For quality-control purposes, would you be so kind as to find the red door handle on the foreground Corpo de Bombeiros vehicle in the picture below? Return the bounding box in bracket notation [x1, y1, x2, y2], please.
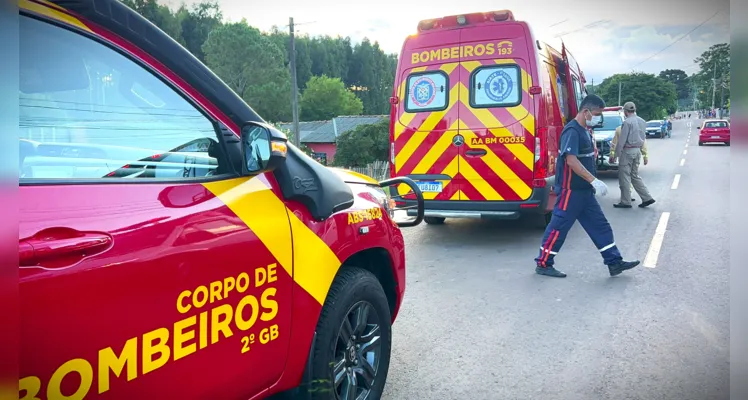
[18, 228, 112, 268]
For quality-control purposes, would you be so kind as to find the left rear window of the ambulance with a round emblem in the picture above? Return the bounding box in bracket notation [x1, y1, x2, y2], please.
[405, 71, 449, 113]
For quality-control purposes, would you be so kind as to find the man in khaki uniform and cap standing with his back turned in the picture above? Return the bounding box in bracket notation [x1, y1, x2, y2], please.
[610, 101, 655, 208]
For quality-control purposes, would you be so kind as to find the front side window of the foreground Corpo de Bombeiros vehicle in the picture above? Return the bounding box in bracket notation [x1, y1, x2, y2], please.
[19, 16, 225, 182]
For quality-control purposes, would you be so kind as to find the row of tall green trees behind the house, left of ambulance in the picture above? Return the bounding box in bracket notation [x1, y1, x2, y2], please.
[121, 0, 397, 121]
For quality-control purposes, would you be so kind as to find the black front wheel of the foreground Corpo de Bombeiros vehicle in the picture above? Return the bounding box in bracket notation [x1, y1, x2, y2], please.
[309, 267, 392, 400]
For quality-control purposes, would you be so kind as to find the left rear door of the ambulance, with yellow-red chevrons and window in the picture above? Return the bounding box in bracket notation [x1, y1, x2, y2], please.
[392, 30, 460, 200]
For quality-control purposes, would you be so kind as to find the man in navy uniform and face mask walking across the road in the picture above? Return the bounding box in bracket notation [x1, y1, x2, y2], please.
[535, 95, 639, 278]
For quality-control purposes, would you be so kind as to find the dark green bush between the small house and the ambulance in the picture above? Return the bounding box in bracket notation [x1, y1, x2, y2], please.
[335, 119, 390, 167]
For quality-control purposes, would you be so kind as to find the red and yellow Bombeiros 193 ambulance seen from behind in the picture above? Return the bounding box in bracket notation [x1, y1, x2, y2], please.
[390, 10, 586, 227]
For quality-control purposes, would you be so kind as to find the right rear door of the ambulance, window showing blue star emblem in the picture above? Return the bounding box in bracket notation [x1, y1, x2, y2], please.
[459, 22, 537, 201]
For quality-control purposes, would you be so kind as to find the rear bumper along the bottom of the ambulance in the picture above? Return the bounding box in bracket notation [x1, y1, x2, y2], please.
[405, 177, 555, 219]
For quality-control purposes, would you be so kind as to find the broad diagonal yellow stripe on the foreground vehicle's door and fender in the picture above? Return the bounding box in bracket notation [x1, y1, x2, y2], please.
[203, 177, 341, 305]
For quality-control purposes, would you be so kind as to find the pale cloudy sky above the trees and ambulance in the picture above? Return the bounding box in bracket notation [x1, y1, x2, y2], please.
[161, 0, 730, 83]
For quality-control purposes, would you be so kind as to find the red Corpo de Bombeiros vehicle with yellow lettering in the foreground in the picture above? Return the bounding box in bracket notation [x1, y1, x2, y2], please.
[18, 0, 423, 400]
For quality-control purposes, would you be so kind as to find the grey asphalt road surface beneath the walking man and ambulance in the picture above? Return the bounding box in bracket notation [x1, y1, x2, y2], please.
[384, 116, 730, 400]
